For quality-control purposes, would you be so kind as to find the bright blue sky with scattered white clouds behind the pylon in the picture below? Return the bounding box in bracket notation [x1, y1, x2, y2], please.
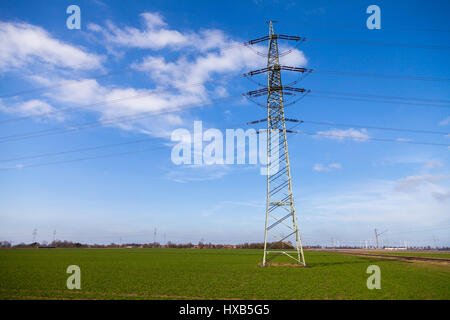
[0, 1, 450, 246]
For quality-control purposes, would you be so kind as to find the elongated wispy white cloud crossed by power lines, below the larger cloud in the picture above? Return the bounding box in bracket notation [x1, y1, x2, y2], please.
[38, 79, 200, 137]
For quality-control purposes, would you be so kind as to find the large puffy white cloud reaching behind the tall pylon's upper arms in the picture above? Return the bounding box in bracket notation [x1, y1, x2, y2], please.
[93, 12, 306, 92]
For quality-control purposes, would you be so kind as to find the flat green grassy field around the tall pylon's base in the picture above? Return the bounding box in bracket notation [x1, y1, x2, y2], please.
[0, 249, 450, 299]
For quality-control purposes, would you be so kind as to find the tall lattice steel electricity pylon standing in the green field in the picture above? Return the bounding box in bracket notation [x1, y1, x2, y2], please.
[244, 21, 311, 266]
